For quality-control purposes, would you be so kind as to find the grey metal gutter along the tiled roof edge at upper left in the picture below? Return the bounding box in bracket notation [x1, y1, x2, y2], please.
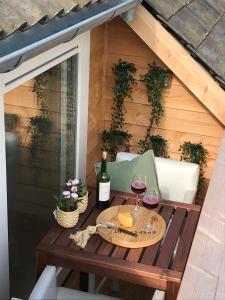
[0, 0, 141, 73]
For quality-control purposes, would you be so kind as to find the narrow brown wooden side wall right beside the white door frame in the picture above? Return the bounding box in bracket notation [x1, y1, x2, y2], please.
[87, 25, 105, 185]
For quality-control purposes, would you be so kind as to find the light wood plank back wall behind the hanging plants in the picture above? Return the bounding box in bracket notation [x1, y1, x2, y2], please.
[89, 17, 223, 199]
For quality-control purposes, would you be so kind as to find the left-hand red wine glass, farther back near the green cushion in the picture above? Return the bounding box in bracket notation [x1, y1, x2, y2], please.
[131, 173, 146, 214]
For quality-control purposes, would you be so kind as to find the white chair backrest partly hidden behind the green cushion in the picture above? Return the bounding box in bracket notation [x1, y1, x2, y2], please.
[116, 152, 199, 203]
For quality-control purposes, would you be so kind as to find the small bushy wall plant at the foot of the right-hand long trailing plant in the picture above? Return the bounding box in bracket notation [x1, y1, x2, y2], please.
[138, 135, 169, 158]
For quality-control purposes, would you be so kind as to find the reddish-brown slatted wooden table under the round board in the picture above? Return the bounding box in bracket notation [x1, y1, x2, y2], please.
[36, 189, 200, 300]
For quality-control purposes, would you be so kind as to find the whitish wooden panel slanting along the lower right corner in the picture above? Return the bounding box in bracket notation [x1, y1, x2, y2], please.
[177, 135, 225, 300]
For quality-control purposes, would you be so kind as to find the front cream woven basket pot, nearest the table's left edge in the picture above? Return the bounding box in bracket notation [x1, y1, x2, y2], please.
[56, 206, 79, 228]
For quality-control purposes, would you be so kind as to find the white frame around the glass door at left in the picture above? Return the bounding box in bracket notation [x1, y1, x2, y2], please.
[0, 31, 90, 299]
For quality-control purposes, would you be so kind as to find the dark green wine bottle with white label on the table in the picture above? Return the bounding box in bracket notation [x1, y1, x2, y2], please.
[96, 151, 110, 210]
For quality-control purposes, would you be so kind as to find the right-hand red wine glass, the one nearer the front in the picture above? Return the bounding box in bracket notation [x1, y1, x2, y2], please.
[142, 188, 160, 233]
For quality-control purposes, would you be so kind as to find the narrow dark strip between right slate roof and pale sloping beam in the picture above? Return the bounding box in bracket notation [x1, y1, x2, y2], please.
[142, 1, 225, 90]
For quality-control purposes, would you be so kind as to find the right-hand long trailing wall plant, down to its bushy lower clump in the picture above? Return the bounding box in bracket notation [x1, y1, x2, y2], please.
[138, 64, 172, 157]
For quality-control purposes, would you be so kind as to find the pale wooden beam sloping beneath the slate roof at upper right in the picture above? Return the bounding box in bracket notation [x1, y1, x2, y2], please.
[125, 5, 225, 125]
